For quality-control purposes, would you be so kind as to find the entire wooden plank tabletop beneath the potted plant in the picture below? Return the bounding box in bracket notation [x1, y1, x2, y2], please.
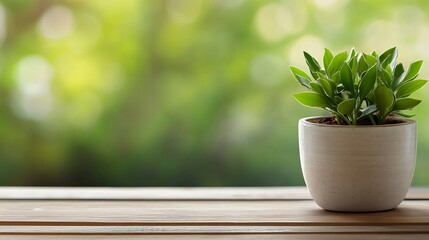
[0, 187, 429, 240]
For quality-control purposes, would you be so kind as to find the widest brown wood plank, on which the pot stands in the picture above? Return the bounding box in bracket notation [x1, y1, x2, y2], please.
[0, 200, 429, 226]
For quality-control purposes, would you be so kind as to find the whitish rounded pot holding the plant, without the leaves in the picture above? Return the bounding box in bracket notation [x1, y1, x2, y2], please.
[299, 118, 417, 212]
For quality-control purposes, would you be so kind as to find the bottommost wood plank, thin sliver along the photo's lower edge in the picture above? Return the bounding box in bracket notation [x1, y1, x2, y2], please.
[1, 233, 429, 240]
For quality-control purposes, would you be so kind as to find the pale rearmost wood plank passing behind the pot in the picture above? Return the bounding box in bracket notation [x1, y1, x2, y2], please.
[0, 187, 429, 201]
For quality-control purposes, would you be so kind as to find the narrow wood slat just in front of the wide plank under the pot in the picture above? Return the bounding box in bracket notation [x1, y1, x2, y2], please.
[0, 224, 429, 235]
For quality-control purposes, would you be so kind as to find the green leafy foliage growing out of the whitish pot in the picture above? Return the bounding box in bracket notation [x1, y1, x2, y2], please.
[290, 47, 427, 125]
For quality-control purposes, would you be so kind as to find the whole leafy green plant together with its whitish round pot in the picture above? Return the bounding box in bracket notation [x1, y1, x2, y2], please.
[290, 47, 427, 212]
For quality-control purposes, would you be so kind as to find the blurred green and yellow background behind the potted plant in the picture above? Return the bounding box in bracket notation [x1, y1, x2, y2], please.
[0, 0, 429, 186]
